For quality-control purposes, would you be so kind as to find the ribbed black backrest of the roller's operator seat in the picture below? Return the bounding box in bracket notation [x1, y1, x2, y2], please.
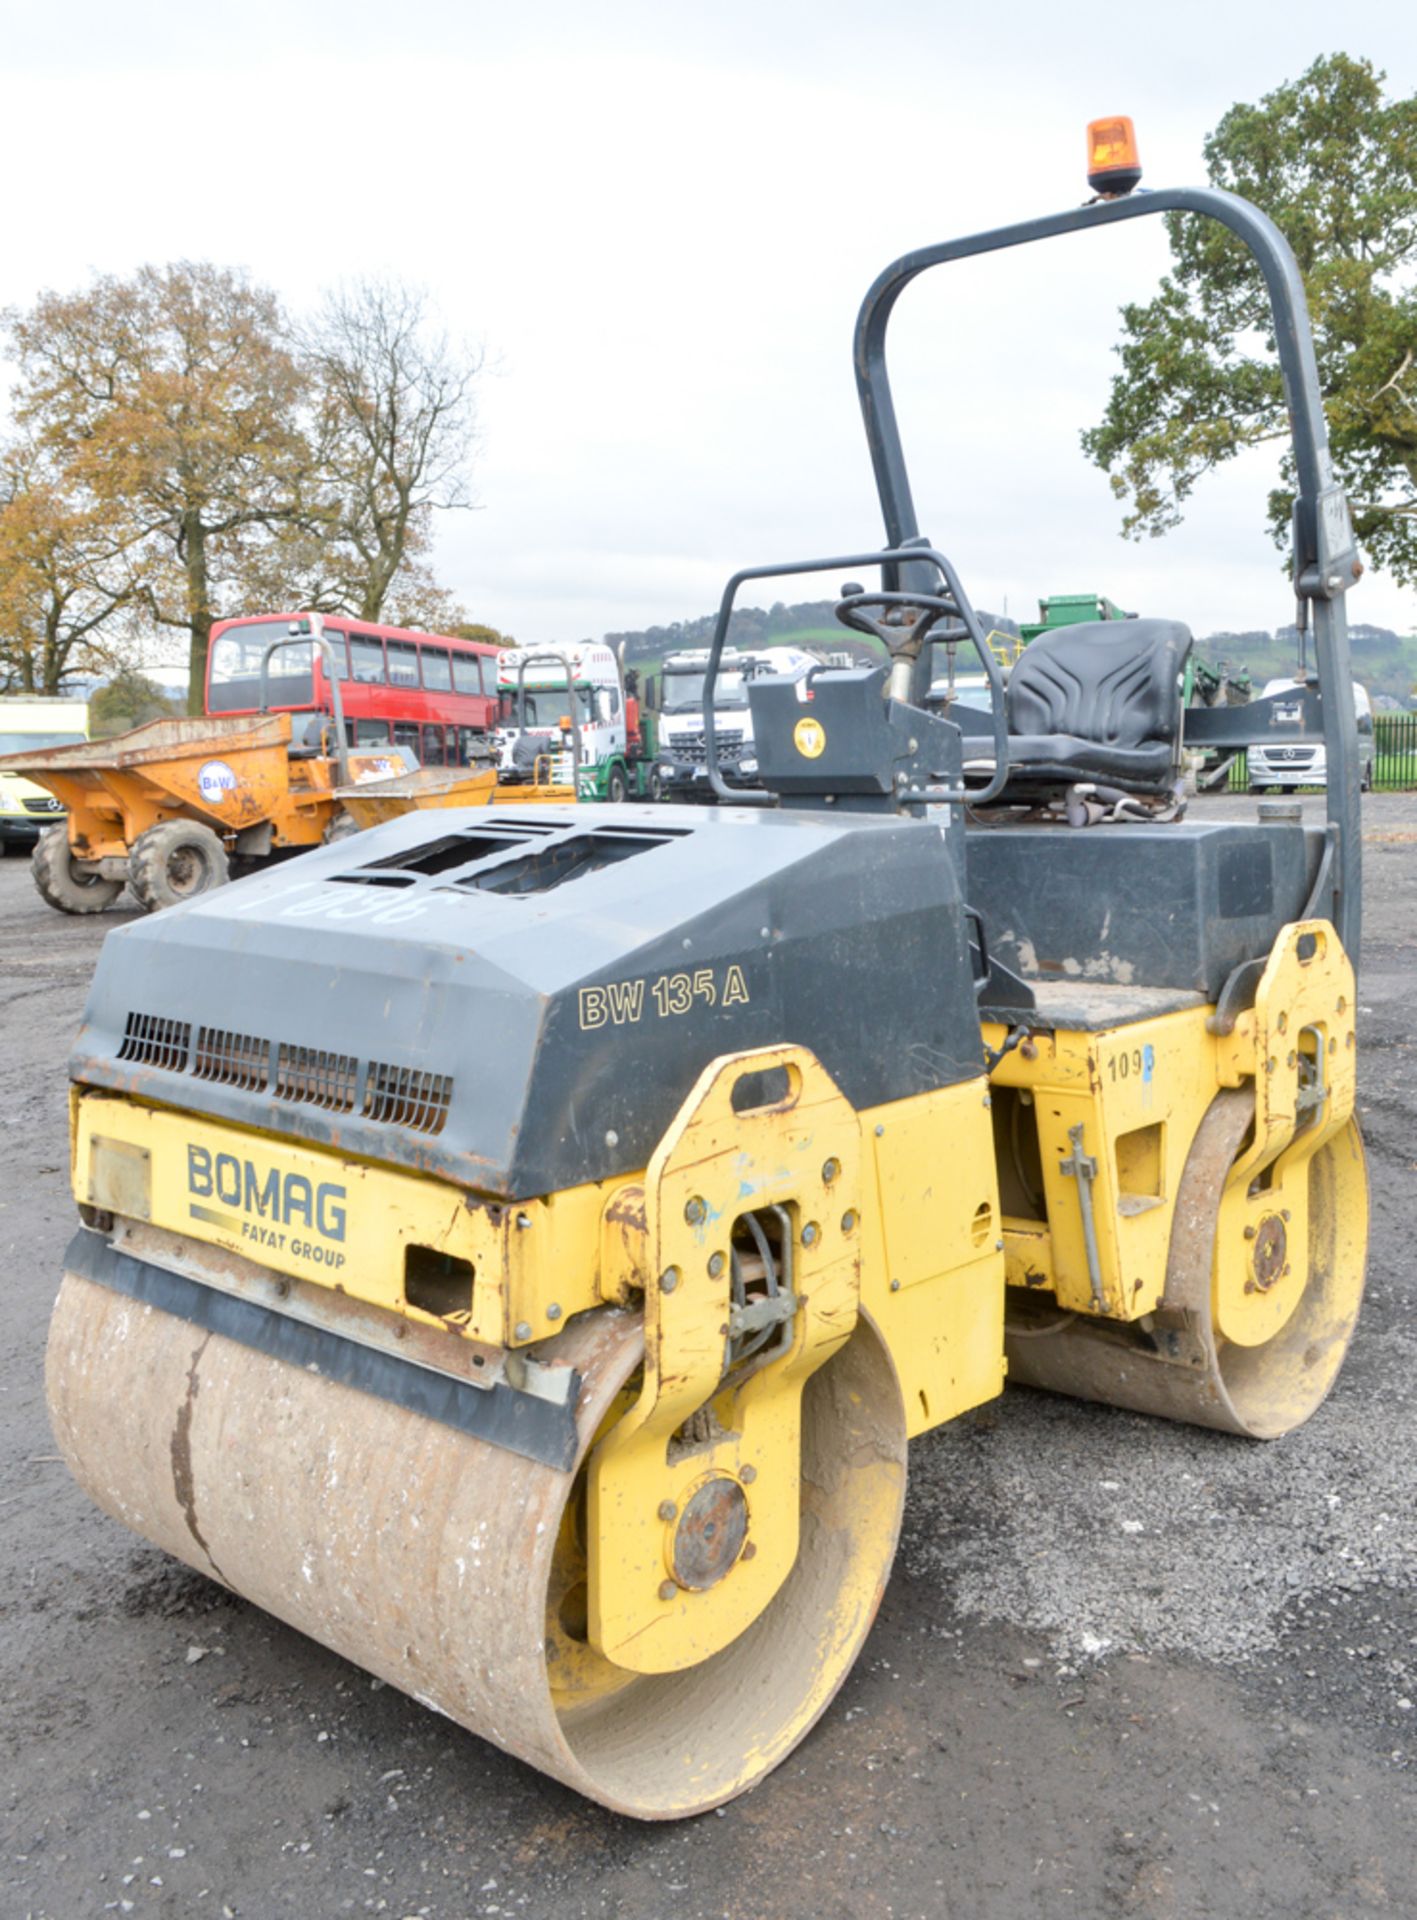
[1008, 620, 1190, 747]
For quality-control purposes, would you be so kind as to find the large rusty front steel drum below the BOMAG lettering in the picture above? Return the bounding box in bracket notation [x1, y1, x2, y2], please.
[48, 1273, 906, 1820]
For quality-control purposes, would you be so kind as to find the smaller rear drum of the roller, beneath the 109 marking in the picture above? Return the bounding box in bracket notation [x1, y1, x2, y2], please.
[1004, 1089, 1367, 1440]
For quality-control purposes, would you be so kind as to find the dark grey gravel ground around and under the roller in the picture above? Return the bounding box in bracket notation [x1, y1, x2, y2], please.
[0, 795, 1417, 1920]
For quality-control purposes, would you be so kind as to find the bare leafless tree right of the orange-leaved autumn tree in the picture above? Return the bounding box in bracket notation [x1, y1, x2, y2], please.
[301, 280, 484, 620]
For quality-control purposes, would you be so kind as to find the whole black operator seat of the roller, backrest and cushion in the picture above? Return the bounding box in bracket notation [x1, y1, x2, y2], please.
[966, 620, 1190, 806]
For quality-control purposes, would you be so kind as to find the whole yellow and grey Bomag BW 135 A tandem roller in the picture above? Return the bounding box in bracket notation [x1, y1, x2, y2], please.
[48, 131, 1367, 1818]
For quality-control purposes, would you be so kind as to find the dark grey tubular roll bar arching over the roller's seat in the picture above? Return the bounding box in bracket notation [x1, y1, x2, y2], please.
[854, 186, 1363, 968]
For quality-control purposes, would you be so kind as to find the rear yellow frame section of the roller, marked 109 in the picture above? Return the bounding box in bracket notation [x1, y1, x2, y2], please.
[985, 922, 1356, 1344]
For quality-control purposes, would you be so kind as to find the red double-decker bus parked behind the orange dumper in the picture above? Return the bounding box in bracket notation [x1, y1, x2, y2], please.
[205, 612, 497, 766]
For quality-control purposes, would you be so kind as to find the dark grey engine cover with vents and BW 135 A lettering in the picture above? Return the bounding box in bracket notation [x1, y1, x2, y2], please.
[71, 806, 981, 1200]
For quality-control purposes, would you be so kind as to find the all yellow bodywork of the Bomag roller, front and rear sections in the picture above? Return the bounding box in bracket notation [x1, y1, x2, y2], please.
[73, 922, 1354, 1672]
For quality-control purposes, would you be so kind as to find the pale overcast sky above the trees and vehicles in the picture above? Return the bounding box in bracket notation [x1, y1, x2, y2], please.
[0, 0, 1417, 641]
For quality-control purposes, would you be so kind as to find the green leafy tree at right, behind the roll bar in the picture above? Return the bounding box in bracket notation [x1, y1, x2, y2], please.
[1083, 54, 1417, 586]
